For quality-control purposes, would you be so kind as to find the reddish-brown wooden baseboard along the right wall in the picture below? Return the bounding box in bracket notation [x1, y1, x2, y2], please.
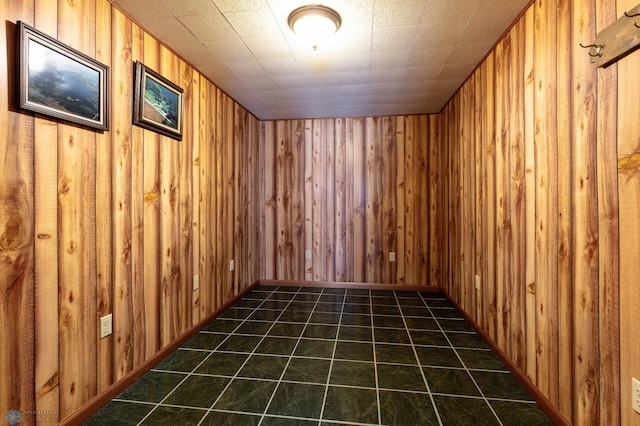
[444, 294, 571, 426]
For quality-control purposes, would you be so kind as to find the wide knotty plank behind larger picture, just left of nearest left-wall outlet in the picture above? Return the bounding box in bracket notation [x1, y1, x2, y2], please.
[57, 0, 98, 418]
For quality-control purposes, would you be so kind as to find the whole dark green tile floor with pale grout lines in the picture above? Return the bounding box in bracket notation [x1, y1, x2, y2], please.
[85, 286, 552, 426]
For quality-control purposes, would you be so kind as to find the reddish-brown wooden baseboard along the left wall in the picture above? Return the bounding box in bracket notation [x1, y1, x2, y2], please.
[59, 281, 258, 426]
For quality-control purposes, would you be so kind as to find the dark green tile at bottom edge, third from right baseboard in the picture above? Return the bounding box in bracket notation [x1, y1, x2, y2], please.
[380, 390, 438, 426]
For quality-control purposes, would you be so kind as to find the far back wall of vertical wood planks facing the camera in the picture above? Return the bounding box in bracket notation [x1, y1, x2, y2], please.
[260, 115, 441, 285]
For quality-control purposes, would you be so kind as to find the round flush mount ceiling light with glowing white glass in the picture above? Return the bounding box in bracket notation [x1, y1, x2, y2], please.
[289, 4, 342, 50]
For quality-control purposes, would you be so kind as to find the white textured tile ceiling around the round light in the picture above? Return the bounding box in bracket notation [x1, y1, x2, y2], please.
[112, 0, 530, 120]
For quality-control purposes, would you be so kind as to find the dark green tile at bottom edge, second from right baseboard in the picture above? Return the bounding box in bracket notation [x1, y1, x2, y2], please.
[433, 395, 500, 426]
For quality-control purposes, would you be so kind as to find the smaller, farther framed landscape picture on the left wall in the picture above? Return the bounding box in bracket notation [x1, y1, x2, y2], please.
[133, 61, 183, 140]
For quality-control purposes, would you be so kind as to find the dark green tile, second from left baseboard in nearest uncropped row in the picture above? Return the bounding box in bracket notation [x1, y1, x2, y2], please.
[162, 376, 231, 408]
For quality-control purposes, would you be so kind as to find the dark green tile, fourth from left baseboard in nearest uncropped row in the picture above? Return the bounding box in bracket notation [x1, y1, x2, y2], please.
[267, 383, 325, 419]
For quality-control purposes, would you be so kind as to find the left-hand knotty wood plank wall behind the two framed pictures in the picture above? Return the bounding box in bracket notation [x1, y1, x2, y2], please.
[0, 0, 259, 424]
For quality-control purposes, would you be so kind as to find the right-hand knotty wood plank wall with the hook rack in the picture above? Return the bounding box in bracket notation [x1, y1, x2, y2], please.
[439, 0, 640, 425]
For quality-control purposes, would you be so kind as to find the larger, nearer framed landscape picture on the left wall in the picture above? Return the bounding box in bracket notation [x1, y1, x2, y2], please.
[18, 22, 109, 130]
